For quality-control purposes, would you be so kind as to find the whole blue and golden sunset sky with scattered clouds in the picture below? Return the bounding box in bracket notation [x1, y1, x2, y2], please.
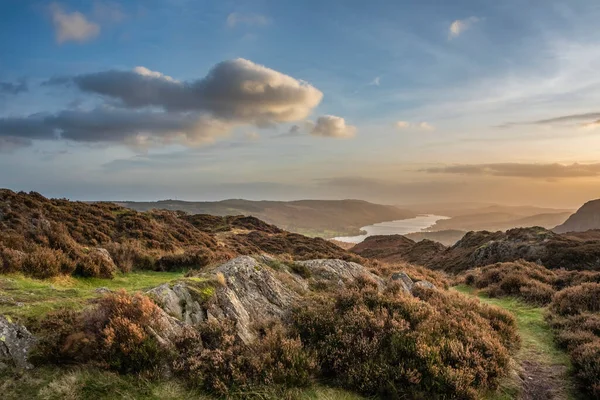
[0, 0, 600, 207]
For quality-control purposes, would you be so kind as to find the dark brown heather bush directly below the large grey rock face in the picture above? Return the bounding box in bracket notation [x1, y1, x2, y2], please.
[174, 320, 316, 395]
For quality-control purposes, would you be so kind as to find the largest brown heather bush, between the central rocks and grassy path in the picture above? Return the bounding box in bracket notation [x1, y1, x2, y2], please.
[292, 280, 517, 399]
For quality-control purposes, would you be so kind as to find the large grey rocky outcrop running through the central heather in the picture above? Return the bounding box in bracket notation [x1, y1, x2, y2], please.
[147, 255, 440, 343]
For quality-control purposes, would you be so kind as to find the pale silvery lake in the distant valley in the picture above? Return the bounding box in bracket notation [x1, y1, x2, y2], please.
[334, 214, 450, 243]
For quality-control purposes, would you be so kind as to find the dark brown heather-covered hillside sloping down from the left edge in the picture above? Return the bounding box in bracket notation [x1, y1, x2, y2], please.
[0, 190, 353, 277]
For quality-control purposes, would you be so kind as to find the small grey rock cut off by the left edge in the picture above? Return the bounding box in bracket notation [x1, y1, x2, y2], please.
[0, 316, 36, 369]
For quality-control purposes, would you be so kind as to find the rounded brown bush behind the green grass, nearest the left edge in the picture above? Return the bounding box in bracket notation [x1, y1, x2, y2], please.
[21, 247, 75, 279]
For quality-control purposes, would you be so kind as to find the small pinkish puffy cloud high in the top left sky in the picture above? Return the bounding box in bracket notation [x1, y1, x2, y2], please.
[50, 3, 100, 44]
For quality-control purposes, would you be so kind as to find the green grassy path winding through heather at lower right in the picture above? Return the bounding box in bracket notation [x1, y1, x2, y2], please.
[454, 285, 577, 400]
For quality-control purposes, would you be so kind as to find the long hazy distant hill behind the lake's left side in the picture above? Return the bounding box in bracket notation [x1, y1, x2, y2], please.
[118, 200, 417, 237]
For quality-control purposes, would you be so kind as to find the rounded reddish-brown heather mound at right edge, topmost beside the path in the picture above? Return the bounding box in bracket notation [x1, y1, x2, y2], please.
[550, 283, 600, 315]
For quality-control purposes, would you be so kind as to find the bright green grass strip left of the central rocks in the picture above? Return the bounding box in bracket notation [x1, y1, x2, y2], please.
[0, 271, 184, 320]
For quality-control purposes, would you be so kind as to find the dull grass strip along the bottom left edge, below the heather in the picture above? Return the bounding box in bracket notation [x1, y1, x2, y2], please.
[0, 367, 365, 400]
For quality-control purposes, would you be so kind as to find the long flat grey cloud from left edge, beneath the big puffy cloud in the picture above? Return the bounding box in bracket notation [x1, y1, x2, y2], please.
[0, 108, 233, 148]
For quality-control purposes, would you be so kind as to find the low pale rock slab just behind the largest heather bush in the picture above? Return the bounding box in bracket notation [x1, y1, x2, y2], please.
[296, 259, 384, 287]
